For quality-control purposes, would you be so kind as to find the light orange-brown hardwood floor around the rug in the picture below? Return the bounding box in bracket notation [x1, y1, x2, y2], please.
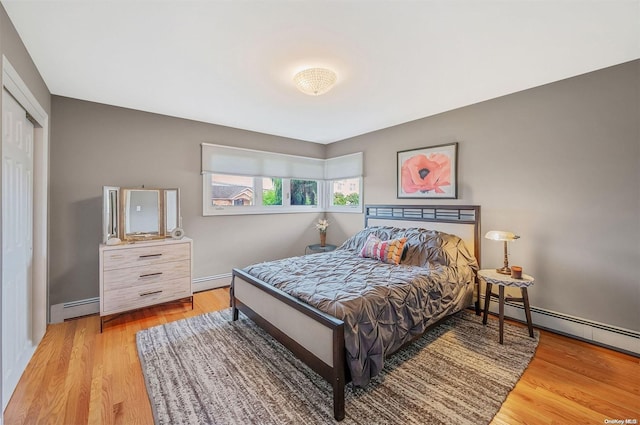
[4, 289, 640, 425]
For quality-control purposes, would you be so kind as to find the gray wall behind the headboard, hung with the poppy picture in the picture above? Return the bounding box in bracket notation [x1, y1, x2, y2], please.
[327, 61, 640, 331]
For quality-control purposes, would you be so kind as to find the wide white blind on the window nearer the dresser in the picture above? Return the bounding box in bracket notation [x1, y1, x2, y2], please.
[202, 143, 325, 180]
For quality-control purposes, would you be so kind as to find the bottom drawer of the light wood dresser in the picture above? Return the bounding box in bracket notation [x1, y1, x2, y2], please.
[101, 277, 192, 316]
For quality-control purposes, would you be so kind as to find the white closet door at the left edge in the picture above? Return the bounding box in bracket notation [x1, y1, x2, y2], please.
[2, 90, 34, 410]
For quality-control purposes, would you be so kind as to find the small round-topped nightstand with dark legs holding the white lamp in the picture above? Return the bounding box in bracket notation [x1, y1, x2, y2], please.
[478, 269, 535, 344]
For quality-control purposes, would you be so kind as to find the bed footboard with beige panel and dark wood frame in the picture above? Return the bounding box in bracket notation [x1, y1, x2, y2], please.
[230, 269, 346, 421]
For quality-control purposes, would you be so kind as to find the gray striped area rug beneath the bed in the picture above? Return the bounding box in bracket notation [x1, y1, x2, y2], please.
[136, 310, 539, 425]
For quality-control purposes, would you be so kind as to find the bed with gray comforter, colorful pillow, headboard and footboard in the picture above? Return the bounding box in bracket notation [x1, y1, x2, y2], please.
[230, 205, 480, 420]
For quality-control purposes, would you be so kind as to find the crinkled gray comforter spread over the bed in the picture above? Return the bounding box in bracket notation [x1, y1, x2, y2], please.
[245, 227, 478, 386]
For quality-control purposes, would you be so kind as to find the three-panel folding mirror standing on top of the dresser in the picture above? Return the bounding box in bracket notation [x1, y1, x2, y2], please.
[102, 186, 181, 243]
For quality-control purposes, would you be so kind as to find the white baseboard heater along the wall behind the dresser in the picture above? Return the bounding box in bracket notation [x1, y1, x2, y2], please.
[51, 273, 231, 323]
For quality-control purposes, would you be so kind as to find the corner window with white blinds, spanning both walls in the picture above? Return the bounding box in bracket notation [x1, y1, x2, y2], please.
[202, 143, 362, 215]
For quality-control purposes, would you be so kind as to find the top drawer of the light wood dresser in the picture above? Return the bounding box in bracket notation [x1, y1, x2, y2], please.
[102, 243, 191, 271]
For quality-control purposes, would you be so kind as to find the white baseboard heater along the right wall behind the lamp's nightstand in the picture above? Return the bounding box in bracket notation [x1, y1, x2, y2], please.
[480, 295, 640, 356]
